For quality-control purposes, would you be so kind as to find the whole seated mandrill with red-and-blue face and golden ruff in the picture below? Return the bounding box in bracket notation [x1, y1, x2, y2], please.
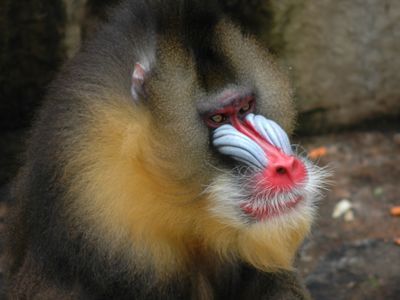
[7, 0, 325, 300]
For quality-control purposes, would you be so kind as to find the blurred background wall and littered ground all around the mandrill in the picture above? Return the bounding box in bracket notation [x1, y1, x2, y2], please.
[0, 0, 400, 299]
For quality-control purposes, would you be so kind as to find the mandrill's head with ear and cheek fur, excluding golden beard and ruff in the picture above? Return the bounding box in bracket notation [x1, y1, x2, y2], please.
[131, 22, 325, 226]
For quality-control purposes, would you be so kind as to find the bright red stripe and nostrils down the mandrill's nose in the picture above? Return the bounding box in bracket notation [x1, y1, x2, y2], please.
[231, 116, 307, 192]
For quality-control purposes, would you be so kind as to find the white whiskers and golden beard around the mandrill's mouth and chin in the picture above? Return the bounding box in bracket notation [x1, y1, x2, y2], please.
[203, 157, 330, 271]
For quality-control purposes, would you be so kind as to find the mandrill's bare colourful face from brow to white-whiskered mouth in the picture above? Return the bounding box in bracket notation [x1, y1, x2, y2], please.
[198, 89, 322, 227]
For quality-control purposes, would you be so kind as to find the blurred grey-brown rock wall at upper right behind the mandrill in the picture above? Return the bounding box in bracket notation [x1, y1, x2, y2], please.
[266, 0, 400, 130]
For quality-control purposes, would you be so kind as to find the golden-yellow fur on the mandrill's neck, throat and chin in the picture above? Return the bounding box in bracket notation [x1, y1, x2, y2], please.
[61, 101, 311, 278]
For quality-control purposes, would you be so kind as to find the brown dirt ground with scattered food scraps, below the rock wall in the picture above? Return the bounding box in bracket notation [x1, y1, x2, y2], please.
[0, 129, 400, 300]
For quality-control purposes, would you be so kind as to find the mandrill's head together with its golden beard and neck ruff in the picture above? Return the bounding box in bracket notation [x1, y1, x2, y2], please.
[73, 14, 325, 272]
